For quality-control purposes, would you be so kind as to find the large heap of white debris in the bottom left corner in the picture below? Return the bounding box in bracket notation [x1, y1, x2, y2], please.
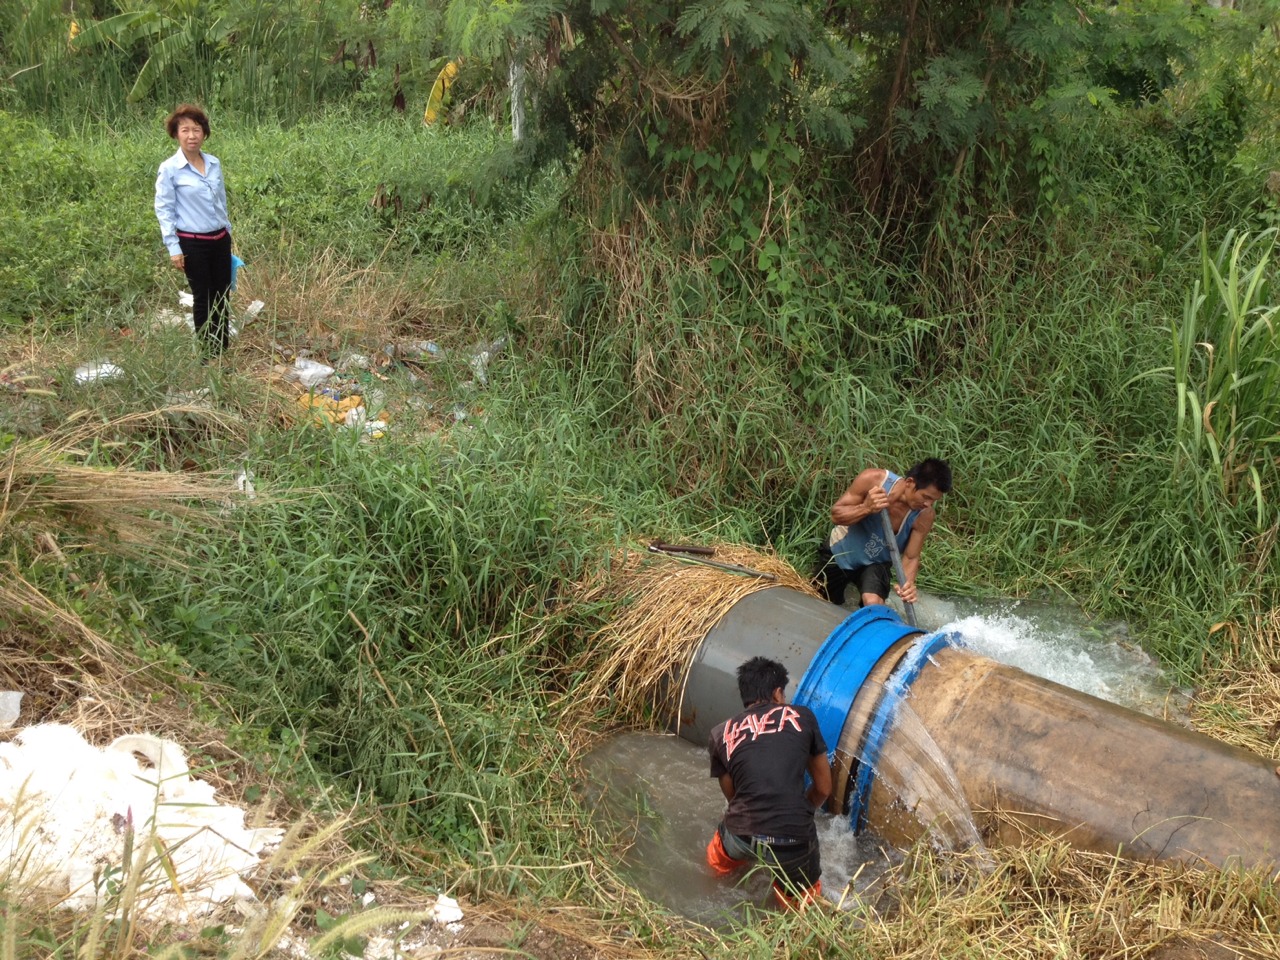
[0, 723, 284, 922]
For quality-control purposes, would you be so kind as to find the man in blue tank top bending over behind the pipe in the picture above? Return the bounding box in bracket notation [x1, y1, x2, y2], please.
[813, 457, 951, 607]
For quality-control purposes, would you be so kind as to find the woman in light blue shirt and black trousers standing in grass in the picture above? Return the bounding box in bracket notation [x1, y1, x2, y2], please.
[156, 104, 232, 356]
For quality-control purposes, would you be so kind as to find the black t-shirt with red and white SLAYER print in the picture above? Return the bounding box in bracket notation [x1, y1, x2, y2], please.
[708, 701, 827, 840]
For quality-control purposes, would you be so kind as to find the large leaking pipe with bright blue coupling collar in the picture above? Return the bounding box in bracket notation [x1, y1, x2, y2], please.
[678, 588, 1280, 870]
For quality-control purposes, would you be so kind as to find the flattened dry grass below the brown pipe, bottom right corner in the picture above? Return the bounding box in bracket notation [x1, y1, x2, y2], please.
[846, 840, 1280, 960]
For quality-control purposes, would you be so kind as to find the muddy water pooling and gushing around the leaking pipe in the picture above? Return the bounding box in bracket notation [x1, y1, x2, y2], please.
[584, 598, 1185, 925]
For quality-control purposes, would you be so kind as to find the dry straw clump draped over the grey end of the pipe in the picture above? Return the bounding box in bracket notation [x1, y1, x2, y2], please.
[559, 544, 815, 727]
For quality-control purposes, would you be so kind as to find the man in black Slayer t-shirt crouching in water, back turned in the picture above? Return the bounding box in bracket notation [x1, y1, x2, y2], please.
[707, 657, 831, 908]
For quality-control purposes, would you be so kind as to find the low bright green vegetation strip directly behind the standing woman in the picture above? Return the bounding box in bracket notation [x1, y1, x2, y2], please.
[0, 111, 559, 329]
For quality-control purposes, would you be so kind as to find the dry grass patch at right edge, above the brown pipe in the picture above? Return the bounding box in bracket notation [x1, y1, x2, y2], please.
[1192, 609, 1280, 759]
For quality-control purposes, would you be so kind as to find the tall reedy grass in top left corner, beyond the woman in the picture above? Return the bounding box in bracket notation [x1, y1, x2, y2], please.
[0, 0, 376, 124]
